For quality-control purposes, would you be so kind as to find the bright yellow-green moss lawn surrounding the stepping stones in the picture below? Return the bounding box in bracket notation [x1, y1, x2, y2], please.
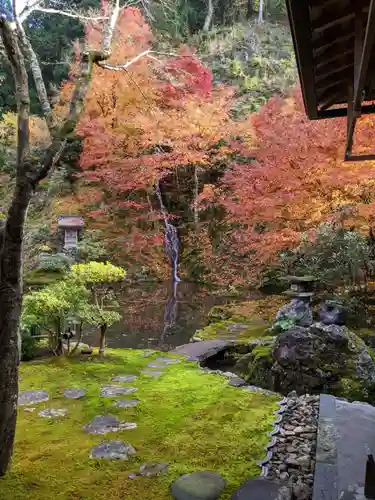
[0, 350, 276, 500]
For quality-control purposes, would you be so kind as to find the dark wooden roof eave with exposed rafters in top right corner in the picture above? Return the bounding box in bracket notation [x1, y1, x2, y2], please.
[286, 0, 375, 159]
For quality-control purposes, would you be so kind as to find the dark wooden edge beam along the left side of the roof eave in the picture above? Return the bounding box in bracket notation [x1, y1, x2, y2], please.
[286, 0, 318, 119]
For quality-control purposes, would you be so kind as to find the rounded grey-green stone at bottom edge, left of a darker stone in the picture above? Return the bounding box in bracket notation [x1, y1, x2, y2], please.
[172, 471, 228, 500]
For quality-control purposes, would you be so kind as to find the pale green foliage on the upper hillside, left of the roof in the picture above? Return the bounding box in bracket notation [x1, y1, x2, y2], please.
[199, 22, 297, 117]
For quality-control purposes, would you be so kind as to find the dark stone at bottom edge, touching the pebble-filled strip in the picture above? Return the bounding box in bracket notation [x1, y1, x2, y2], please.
[232, 477, 292, 500]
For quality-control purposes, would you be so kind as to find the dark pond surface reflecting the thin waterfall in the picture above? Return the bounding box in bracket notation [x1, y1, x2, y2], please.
[83, 281, 256, 351]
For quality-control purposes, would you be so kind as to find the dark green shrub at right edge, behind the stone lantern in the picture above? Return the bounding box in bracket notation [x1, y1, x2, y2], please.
[281, 223, 374, 289]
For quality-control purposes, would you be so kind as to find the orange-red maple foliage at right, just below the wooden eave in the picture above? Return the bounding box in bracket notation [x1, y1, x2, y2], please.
[214, 92, 375, 284]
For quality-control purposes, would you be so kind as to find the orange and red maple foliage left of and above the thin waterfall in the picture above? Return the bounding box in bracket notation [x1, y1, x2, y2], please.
[56, 8, 250, 274]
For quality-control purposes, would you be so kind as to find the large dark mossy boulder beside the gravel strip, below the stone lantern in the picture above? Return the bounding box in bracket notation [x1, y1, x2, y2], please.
[234, 323, 375, 401]
